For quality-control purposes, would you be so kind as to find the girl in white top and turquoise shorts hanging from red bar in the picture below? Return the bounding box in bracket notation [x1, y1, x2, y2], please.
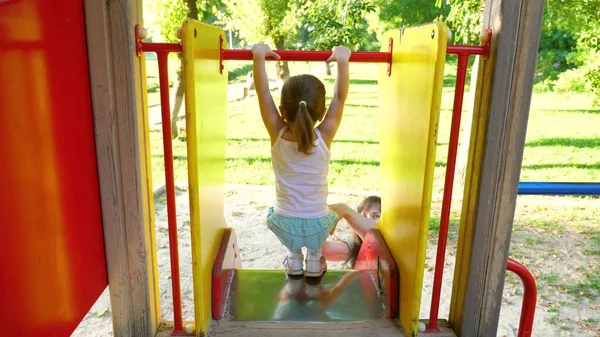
[252, 43, 351, 277]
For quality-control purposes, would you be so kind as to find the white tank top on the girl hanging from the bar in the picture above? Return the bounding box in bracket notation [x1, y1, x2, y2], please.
[271, 126, 331, 219]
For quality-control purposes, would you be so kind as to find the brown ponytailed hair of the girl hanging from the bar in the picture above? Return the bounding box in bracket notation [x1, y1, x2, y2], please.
[281, 75, 325, 154]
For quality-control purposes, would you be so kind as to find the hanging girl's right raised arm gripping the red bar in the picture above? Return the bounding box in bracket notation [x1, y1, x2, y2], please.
[319, 46, 350, 147]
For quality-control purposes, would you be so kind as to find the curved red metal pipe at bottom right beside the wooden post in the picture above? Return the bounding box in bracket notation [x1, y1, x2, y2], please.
[506, 259, 537, 337]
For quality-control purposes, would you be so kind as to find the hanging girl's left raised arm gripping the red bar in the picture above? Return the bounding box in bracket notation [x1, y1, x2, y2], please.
[252, 43, 285, 145]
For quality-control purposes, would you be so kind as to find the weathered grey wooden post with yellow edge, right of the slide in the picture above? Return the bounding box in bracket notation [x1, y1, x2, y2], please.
[450, 0, 544, 336]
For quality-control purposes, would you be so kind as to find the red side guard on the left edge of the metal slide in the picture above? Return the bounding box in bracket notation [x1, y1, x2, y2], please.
[212, 228, 242, 320]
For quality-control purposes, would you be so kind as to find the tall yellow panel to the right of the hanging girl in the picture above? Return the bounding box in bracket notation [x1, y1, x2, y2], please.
[378, 23, 448, 336]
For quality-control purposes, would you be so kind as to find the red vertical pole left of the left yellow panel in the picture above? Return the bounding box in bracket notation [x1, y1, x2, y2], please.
[156, 51, 183, 335]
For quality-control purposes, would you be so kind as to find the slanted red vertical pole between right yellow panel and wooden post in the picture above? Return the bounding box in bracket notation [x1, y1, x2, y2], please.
[426, 54, 469, 332]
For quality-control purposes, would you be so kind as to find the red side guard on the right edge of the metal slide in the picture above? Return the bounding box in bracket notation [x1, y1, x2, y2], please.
[354, 229, 400, 319]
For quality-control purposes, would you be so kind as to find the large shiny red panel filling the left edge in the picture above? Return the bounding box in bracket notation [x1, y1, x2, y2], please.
[0, 0, 107, 336]
